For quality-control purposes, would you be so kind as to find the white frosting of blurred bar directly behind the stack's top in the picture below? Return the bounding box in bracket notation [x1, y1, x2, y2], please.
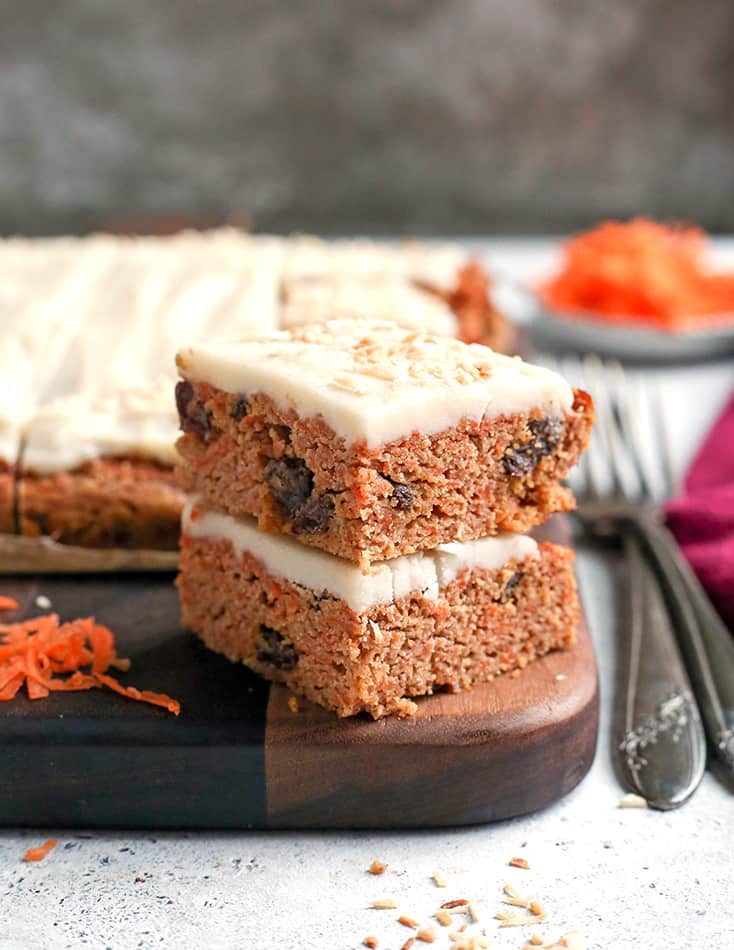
[281, 276, 458, 336]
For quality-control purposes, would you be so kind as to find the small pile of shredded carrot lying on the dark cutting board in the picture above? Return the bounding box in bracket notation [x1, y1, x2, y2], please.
[0, 597, 181, 716]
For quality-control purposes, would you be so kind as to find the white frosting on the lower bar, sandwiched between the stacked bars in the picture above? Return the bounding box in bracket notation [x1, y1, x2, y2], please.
[182, 502, 538, 613]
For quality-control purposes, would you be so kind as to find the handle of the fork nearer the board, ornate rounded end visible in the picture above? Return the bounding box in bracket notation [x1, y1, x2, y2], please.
[615, 526, 706, 809]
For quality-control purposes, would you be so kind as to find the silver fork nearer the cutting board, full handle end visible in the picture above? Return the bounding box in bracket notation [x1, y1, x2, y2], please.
[548, 359, 706, 809]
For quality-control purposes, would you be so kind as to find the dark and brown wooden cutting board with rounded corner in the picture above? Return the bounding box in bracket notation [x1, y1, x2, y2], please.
[0, 525, 598, 829]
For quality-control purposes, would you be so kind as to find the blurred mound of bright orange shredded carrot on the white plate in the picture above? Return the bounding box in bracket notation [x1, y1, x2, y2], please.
[539, 218, 734, 331]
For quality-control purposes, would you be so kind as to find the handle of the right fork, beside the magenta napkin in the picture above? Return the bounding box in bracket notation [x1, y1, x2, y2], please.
[634, 517, 734, 780]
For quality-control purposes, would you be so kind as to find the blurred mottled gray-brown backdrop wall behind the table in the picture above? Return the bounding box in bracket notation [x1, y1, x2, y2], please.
[0, 0, 734, 234]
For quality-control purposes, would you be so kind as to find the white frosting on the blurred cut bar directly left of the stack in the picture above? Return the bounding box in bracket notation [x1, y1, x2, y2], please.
[23, 379, 178, 474]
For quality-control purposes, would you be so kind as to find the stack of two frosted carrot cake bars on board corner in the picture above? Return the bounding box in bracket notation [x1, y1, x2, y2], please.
[176, 320, 593, 718]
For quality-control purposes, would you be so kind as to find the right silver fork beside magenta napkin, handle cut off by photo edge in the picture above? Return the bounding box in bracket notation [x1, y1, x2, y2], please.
[568, 356, 734, 781]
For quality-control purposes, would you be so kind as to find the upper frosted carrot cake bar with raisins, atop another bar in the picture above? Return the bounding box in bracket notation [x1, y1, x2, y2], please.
[176, 321, 593, 566]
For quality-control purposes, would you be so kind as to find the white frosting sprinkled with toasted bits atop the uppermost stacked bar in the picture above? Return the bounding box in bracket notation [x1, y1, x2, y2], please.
[177, 321, 573, 446]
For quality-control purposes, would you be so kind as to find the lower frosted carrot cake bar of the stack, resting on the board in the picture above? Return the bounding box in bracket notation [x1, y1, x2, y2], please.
[177, 503, 579, 719]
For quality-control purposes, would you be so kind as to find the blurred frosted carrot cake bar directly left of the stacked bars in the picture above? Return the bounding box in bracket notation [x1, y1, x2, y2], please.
[16, 380, 185, 550]
